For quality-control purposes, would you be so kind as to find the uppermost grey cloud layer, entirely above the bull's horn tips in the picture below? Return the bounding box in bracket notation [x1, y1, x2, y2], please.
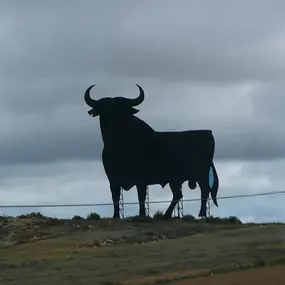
[2, 1, 284, 84]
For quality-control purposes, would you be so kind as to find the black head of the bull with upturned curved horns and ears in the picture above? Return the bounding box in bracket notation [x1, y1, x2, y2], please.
[84, 84, 144, 117]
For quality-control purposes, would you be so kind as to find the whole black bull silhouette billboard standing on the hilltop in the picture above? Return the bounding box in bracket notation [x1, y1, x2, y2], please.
[84, 85, 219, 219]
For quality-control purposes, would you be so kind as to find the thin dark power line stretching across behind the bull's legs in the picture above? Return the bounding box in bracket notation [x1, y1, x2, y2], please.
[0, 190, 285, 208]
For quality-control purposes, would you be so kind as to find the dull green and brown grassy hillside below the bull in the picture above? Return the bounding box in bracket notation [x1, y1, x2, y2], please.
[0, 214, 285, 285]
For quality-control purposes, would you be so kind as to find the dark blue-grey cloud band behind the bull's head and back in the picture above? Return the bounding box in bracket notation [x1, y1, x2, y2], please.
[0, 80, 285, 164]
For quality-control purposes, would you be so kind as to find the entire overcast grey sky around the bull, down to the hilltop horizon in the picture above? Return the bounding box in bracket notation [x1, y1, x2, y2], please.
[0, 0, 285, 222]
